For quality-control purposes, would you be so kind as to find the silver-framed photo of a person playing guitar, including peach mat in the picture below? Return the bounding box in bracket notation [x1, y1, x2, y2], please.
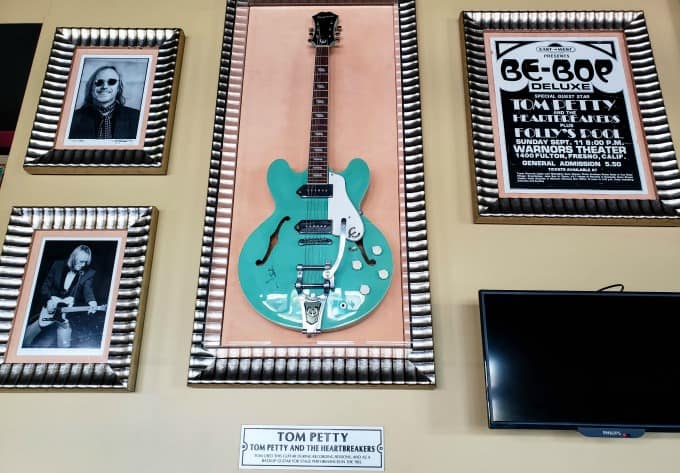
[0, 207, 157, 390]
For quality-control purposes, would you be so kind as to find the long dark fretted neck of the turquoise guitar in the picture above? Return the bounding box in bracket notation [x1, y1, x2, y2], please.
[307, 46, 330, 184]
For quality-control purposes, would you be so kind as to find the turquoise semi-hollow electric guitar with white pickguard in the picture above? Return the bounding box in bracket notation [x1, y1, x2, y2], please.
[238, 12, 392, 336]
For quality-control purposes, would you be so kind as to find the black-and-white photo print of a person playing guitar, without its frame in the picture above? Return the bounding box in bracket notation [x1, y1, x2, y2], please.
[18, 238, 120, 355]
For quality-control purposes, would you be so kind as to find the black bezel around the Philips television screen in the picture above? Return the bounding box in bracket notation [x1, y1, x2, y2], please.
[478, 289, 680, 437]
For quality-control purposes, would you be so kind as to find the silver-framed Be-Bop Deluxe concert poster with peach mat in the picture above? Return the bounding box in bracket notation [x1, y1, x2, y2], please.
[461, 11, 680, 225]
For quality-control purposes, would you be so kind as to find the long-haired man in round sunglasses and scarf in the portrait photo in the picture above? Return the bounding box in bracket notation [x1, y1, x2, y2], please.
[68, 66, 139, 140]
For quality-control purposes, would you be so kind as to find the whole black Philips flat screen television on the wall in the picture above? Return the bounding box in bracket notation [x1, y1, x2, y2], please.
[479, 290, 680, 437]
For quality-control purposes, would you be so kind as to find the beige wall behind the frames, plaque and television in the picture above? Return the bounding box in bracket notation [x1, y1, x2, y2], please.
[0, 0, 680, 473]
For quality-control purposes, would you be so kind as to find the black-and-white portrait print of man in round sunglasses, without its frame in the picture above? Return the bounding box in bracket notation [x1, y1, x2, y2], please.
[64, 54, 153, 146]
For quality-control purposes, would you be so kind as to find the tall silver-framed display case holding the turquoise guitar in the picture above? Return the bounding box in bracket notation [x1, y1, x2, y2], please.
[188, 0, 435, 386]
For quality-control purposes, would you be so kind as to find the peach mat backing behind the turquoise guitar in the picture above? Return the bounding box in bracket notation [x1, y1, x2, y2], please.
[216, 6, 408, 346]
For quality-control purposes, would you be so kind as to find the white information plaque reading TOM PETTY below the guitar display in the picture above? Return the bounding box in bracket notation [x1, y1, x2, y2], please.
[239, 425, 385, 471]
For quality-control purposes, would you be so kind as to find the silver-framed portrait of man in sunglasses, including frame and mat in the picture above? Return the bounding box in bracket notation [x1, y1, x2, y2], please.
[24, 28, 184, 174]
